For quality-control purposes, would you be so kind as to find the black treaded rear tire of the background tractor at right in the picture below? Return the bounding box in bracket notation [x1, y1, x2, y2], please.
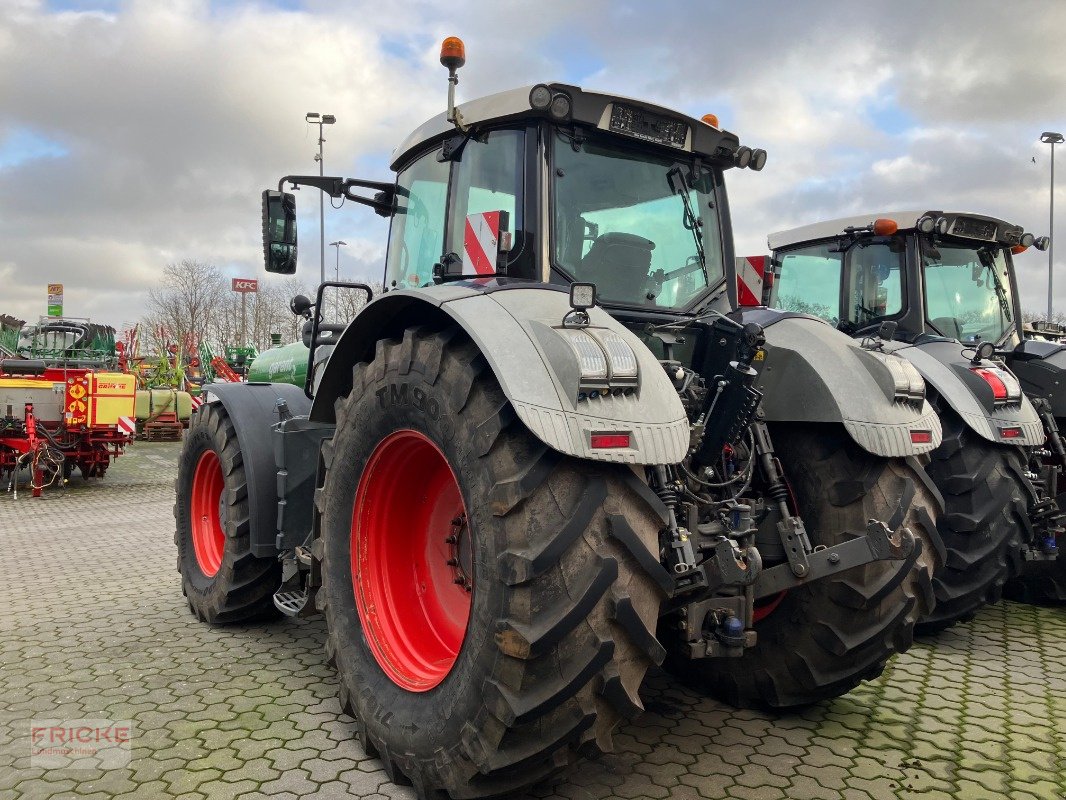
[918, 409, 1035, 635]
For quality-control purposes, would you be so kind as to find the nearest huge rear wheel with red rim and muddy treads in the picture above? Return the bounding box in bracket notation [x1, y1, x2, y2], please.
[317, 329, 663, 798]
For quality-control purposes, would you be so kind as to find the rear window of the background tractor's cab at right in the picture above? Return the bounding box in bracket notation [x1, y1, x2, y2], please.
[921, 239, 1014, 341]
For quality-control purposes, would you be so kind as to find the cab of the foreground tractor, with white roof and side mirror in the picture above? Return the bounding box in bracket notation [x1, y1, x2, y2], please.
[263, 73, 765, 326]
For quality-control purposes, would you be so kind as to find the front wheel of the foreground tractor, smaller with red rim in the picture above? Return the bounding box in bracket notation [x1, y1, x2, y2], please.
[174, 403, 281, 624]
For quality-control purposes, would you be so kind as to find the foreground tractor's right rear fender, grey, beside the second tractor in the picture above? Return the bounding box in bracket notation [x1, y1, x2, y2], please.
[743, 308, 942, 458]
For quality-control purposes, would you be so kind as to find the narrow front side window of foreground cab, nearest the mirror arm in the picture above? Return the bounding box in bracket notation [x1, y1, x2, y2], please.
[385, 151, 450, 289]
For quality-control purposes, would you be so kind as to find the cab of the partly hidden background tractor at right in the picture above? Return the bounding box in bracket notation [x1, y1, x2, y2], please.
[768, 211, 1048, 348]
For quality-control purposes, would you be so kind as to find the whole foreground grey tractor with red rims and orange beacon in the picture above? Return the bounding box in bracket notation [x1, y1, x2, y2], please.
[175, 39, 941, 798]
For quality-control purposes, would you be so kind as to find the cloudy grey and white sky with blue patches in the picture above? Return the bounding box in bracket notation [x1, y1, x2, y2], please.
[0, 0, 1066, 326]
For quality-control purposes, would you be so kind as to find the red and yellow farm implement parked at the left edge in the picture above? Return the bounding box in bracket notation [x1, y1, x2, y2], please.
[0, 318, 134, 497]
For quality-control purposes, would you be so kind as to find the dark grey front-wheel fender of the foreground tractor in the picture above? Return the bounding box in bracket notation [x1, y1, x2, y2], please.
[204, 383, 311, 558]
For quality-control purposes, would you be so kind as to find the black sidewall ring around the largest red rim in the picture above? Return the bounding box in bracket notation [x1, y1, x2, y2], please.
[322, 365, 504, 752]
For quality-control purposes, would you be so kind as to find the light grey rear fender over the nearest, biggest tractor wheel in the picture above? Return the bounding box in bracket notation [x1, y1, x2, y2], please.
[311, 284, 690, 464]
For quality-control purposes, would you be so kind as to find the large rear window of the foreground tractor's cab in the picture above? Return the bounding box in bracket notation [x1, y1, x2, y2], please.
[552, 133, 724, 309]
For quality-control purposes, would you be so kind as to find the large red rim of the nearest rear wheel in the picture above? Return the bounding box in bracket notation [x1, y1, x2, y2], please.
[351, 430, 473, 691]
